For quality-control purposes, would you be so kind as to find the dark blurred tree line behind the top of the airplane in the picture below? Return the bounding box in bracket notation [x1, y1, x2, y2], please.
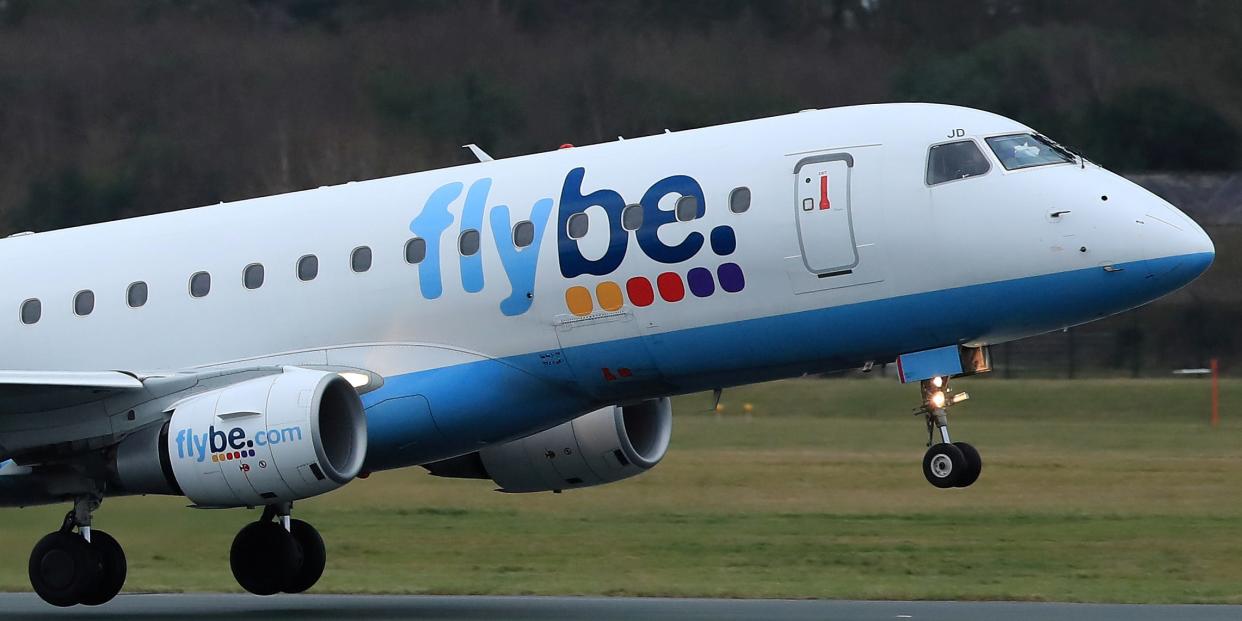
[0, 0, 1242, 232]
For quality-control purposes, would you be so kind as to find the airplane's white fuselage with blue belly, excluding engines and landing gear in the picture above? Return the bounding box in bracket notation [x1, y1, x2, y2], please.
[0, 104, 1212, 466]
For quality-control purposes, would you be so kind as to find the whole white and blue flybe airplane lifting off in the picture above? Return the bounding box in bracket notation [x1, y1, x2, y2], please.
[0, 103, 1215, 606]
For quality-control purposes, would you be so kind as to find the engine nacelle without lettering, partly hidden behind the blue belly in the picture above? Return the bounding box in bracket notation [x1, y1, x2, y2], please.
[425, 397, 673, 492]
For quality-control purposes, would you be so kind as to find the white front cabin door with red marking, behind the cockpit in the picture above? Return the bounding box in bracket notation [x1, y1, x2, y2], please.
[794, 153, 858, 278]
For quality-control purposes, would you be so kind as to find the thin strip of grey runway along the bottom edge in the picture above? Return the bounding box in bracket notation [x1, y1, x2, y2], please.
[0, 594, 1242, 621]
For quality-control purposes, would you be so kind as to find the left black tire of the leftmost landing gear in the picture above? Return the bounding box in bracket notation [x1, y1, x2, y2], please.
[27, 532, 99, 607]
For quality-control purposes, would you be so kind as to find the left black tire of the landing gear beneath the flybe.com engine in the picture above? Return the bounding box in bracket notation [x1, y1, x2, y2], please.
[229, 522, 302, 595]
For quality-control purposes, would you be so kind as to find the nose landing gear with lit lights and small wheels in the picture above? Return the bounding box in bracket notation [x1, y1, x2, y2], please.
[914, 378, 984, 488]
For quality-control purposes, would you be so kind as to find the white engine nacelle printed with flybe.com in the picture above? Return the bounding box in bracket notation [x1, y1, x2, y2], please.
[113, 366, 366, 507]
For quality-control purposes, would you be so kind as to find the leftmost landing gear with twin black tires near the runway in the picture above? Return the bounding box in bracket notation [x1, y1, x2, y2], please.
[29, 497, 128, 607]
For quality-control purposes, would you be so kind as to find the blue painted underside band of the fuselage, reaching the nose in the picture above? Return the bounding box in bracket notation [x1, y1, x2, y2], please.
[364, 252, 1213, 469]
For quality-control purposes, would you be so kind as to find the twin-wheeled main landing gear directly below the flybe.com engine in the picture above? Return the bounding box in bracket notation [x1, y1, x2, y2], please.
[229, 503, 327, 595]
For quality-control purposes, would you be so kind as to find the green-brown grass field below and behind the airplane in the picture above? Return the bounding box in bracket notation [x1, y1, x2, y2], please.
[0, 379, 1242, 602]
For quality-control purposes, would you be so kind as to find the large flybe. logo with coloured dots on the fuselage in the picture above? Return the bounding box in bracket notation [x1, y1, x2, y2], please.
[410, 168, 745, 315]
